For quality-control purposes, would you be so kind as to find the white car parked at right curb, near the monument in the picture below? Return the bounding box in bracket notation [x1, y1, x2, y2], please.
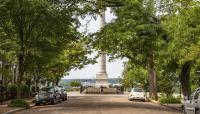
[128, 88, 146, 101]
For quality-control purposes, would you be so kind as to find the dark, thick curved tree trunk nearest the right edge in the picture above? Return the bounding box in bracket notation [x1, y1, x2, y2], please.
[179, 61, 192, 97]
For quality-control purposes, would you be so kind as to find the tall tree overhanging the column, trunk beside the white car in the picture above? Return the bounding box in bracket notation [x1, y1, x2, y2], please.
[94, 0, 166, 99]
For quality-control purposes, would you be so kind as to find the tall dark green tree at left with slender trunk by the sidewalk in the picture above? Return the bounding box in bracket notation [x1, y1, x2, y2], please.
[0, 0, 81, 98]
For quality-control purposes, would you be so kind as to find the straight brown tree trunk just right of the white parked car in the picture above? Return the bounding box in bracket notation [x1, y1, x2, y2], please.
[148, 55, 158, 100]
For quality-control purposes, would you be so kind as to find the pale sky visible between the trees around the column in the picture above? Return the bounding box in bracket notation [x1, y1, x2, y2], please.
[64, 9, 126, 79]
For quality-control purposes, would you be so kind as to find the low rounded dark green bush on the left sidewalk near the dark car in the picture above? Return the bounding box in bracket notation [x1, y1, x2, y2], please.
[8, 99, 30, 109]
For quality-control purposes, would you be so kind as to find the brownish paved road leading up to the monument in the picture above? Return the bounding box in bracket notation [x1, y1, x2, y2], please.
[16, 95, 180, 114]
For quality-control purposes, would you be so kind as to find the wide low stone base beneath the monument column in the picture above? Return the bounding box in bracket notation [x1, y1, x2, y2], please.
[83, 88, 121, 94]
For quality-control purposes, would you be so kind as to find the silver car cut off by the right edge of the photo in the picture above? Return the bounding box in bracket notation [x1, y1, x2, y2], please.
[183, 88, 200, 114]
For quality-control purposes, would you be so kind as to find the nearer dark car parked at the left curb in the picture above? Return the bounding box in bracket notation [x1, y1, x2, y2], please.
[35, 87, 61, 105]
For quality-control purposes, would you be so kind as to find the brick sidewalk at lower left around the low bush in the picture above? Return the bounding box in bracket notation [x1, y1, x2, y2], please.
[0, 98, 35, 114]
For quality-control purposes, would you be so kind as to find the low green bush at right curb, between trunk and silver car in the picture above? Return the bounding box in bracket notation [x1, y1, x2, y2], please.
[160, 97, 181, 104]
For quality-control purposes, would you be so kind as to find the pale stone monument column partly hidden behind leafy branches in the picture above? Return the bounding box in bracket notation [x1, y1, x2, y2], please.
[96, 11, 109, 88]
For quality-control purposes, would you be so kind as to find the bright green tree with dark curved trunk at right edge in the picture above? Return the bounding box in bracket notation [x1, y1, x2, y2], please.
[163, 0, 200, 97]
